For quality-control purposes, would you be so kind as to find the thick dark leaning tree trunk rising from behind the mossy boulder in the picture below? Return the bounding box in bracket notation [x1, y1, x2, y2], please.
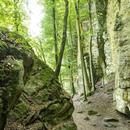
[55, 0, 69, 77]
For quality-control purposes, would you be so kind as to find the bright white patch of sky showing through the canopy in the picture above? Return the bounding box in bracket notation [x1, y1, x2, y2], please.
[27, 0, 43, 37]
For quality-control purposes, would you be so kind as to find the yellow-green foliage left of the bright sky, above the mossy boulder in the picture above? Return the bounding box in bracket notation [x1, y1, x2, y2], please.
[0, 0, 27, 35]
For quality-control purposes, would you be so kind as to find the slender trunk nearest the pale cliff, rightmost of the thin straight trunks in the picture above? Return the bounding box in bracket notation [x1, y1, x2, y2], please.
[88, 0, 95, 91]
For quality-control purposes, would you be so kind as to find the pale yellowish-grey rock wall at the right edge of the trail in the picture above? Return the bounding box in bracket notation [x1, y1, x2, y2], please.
[107, 0, 130, 115]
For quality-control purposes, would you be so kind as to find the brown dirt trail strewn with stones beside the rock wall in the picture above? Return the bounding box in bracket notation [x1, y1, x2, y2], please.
[73, 82, 130, 130]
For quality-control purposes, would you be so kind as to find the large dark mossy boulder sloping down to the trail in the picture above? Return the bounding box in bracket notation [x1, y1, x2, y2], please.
[0, 29, 77, 130]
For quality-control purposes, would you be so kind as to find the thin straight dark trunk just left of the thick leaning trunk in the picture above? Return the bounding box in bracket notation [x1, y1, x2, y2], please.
[52, 0, 58, 65]
